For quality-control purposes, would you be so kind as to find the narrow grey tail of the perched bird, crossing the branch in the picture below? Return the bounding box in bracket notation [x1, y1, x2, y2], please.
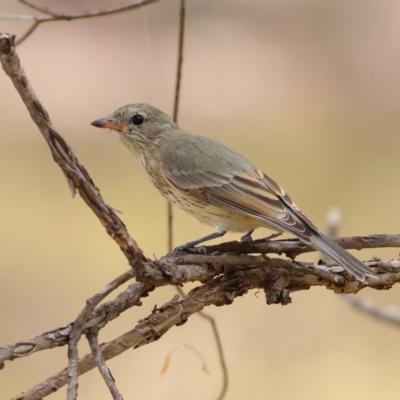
[310, 232, 376, 283]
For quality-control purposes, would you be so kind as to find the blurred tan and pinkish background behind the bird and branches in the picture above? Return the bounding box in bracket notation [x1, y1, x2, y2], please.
[0, 0, 400, 400]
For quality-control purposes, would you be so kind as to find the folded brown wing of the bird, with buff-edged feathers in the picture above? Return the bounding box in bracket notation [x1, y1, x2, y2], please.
[164, 163, 317, 244]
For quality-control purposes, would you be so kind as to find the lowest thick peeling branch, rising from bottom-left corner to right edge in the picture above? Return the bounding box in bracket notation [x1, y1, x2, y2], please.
[13, 257, 400, 400]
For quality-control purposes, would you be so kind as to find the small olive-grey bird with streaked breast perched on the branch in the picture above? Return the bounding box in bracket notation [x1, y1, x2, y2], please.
[92, 104, 376, 282]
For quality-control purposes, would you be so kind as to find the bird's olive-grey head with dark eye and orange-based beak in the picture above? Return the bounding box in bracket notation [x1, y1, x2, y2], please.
[91, 103, 178, 155]
